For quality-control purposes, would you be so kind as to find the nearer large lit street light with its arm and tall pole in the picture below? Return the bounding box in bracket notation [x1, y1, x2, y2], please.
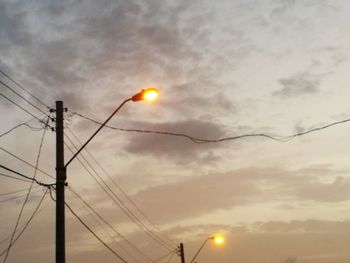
[56, 88, 158, 263]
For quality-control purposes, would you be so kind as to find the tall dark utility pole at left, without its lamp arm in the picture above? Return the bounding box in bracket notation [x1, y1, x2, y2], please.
[56, 101, 66, 263]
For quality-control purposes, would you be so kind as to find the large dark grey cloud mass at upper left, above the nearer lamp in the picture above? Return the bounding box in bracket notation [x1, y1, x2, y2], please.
[1, 1, 241, 117]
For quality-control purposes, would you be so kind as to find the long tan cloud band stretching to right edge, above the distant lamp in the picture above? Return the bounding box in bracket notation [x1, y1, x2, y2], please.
[106, 167, 350, 222]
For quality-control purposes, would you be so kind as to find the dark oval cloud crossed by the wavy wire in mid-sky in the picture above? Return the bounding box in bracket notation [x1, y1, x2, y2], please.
[125, 119, 230, 163]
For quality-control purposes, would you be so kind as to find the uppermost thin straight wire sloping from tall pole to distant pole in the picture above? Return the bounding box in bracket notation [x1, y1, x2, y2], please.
[68, 127, 177, 246]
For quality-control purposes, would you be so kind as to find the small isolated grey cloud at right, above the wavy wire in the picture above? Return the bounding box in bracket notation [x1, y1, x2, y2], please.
[273, 73, 320, 98]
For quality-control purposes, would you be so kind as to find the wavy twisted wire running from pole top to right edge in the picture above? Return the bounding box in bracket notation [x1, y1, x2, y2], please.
[71, 112, 350, 144]
